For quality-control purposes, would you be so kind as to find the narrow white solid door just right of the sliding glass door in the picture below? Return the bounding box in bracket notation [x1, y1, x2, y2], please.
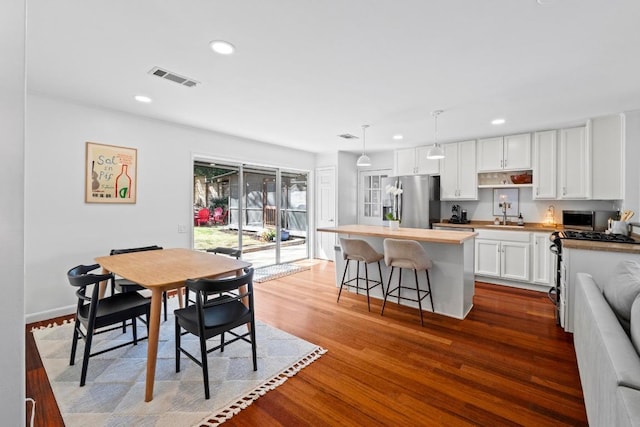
[316, 167, 337, 260]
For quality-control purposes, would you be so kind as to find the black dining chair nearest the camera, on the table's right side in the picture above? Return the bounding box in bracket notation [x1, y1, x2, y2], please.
[174, 268, 258, 399]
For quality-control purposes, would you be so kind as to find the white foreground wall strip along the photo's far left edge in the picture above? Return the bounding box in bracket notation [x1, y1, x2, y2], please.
[0, 0, 25, 426]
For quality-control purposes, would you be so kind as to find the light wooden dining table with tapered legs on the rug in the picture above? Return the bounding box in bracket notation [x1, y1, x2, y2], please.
[95, 248, 251, 402]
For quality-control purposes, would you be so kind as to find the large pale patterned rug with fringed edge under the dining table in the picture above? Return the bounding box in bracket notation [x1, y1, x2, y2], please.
[33, 298, 326, 427]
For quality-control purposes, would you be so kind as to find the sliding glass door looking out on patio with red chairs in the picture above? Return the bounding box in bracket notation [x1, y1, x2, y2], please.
[193, 160, 309, 267]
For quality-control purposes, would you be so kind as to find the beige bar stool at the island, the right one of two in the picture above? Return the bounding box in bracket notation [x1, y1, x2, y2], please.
[380, 239, 434, 326]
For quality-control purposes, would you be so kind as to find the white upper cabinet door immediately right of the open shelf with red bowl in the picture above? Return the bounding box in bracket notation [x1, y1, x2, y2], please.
[533, 130, 558, 199]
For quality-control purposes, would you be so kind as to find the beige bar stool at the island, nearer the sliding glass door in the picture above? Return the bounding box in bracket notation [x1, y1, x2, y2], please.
[337, 237, 384, 311]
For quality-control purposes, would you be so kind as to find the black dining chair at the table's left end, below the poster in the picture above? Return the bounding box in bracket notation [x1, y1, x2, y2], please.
[67, 264, 151, 387]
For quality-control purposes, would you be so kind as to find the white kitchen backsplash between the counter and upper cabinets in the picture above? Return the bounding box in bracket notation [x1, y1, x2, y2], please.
[441, 187, 624, 223]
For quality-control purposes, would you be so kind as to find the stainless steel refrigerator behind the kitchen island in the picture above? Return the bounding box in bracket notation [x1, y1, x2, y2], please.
[382, 175, 440, 228]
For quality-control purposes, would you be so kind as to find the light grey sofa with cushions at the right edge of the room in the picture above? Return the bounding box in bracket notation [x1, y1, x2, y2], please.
[574, 261, 640, 427]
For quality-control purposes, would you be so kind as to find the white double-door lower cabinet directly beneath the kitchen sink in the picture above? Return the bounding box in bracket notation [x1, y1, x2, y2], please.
[475, 229, 531, 282]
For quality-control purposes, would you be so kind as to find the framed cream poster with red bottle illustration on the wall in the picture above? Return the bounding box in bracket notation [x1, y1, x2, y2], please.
[85, 142, 138, 203]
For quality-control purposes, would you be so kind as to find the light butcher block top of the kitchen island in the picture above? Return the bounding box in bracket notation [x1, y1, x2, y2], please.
[317, 224, 478, 245]
